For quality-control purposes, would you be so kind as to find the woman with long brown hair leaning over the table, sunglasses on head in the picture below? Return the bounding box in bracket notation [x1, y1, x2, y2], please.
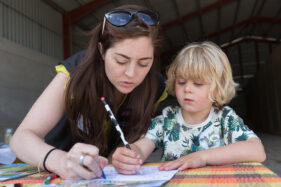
[11, 5, 165, 179]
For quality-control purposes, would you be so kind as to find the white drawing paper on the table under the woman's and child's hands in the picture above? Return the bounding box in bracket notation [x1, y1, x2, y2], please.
[62, 166, 177, 186]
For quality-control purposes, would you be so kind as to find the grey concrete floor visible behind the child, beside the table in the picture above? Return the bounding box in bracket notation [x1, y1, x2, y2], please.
[146, 133, 281, 177]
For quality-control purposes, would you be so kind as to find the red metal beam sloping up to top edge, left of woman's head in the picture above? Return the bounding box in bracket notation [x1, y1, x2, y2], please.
[67, 0, 110, 24]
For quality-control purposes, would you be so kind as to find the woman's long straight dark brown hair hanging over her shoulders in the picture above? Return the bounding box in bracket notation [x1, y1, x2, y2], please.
[65, 5, 160, 156]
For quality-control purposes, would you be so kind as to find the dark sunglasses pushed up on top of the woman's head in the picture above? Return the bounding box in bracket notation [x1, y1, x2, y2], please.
[105, 9, 159, 27]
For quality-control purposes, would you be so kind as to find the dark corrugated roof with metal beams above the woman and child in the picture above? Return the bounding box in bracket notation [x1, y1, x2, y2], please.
[44, 0, 281, 58]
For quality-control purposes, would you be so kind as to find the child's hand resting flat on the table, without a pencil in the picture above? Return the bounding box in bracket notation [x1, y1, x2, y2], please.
[159, 151, 206, 171]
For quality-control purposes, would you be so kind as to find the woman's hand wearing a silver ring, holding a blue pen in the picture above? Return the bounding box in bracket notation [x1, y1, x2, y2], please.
[57, 143, 108, 179]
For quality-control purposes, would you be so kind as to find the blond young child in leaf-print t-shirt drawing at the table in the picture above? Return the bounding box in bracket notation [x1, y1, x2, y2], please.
[112, 42, 266, 174]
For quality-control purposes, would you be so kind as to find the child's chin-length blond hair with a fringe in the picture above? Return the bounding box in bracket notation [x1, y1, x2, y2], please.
[166, 41, 237, 108]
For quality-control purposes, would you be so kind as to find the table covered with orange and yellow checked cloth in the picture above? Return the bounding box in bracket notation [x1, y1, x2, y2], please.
[0, 162, 281, 187]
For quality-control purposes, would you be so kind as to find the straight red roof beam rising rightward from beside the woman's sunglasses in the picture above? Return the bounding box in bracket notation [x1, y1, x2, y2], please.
[162, 0, 233, 29]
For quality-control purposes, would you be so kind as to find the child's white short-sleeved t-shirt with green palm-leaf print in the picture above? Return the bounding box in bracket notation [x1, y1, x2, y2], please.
[145, 106, 258, 161]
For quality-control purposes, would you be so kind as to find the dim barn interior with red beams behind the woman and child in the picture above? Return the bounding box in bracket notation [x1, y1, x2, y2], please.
[0, 0, 281, 176]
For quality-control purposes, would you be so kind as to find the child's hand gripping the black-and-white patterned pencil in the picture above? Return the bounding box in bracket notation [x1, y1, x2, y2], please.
[112, 147, 143, 174]
